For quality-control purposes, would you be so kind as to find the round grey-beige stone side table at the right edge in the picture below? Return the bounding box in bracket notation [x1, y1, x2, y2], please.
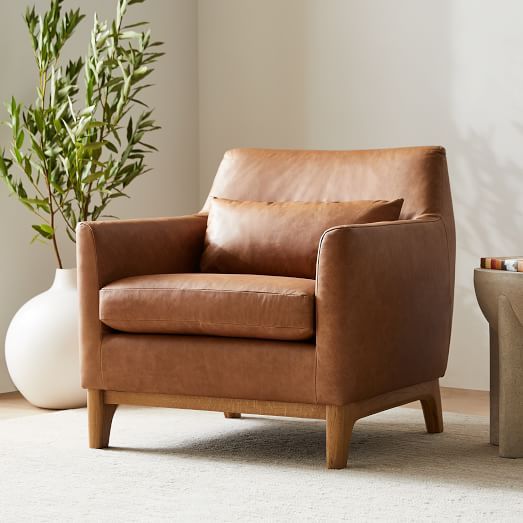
[474, 269, 523, 458]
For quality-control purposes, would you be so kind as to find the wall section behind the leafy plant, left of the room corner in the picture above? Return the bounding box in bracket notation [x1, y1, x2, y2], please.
[0, 0, 199, 392]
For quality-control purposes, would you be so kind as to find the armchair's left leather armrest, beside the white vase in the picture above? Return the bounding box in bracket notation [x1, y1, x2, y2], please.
[76, 214, 207, 389]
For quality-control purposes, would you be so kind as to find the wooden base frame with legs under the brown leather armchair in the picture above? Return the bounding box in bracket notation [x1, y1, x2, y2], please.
[87, 380, 443, 469]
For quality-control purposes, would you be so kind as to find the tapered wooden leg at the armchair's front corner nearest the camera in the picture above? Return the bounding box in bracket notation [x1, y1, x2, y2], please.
[326, 405, 356, 469]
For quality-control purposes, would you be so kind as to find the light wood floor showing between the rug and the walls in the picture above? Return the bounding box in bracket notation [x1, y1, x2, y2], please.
[0, 387, 489, 420]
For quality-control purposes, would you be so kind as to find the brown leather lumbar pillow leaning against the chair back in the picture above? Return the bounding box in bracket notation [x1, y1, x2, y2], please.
[201, 198, 403, 278]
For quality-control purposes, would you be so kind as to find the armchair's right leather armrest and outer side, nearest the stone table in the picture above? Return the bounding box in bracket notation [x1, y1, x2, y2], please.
[316, 217, 454, 405]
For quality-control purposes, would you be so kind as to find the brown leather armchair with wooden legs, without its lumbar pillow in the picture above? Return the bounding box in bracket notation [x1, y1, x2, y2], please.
[77, 147, 455, 468]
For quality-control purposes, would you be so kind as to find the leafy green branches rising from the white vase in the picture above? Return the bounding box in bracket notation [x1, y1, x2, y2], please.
[0, 0, 163, 268]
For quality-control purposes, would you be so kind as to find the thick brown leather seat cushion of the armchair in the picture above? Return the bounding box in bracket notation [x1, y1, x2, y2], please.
[100, 273, 315, 340]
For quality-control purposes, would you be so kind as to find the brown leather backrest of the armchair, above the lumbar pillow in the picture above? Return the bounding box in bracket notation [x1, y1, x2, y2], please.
[203, 147, 455, 278]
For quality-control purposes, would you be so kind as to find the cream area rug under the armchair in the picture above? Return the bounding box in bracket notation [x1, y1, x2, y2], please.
[0, 408, 523, 522]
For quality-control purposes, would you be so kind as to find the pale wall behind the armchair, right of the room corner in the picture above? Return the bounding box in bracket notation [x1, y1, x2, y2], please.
[199, 0, 523, 389]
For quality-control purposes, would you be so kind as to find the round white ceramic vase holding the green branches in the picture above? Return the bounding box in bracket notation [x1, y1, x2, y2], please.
[5, 269, 86, 409]
